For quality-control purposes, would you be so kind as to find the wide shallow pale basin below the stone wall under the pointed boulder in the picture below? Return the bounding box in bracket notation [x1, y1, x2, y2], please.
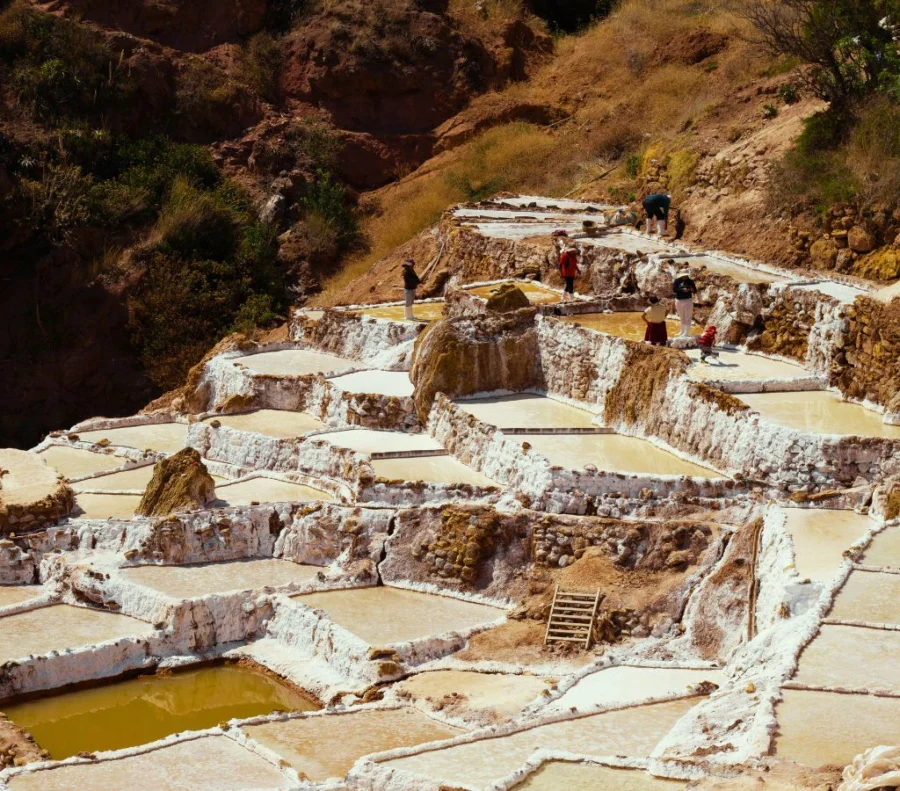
[121, 559, 321, 599]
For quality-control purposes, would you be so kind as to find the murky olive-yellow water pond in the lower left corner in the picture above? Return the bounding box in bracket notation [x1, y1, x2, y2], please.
[5, 665, 319, 760]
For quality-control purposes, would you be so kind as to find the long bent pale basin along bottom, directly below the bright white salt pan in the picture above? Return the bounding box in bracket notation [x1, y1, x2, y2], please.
[385, 699, 698, 788]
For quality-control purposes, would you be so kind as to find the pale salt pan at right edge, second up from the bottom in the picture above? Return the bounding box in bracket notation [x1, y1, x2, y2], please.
[793, 624, 900, 693]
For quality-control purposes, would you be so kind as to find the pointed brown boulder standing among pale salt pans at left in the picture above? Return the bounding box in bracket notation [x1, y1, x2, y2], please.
[136, 448, 216, 516]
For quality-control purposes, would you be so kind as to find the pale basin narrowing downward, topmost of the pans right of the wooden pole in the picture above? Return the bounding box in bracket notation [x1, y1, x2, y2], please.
[784, 508, 874, 581]
